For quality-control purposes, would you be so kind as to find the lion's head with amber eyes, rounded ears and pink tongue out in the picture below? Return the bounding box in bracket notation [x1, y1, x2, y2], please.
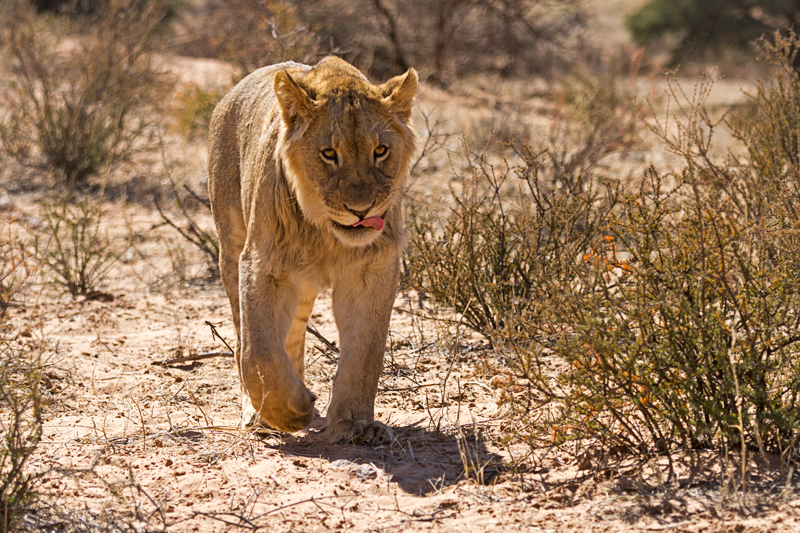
[275, 58, 417, 246]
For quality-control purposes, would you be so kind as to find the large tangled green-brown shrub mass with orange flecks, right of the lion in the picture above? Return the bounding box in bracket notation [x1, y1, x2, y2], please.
[409, 37, 800, 472]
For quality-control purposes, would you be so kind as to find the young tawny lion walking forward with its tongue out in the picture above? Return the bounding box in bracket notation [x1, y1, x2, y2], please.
[208, 57, 418, 444]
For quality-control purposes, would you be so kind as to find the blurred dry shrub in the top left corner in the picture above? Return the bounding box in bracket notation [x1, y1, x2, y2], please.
[0, 0, 169, 184]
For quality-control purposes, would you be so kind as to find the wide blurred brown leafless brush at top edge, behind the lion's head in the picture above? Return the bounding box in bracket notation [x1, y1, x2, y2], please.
[296, 0, 585, 84]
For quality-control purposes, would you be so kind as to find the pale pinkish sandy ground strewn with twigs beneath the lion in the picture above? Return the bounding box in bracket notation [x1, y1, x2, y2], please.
[4, 179, 800, 532]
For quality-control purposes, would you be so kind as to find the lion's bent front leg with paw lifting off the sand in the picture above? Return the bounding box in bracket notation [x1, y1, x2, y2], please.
[239, 252, 316, 431]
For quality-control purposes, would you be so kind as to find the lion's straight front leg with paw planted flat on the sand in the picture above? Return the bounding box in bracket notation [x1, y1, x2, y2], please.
[326, 257, 399, 444]
